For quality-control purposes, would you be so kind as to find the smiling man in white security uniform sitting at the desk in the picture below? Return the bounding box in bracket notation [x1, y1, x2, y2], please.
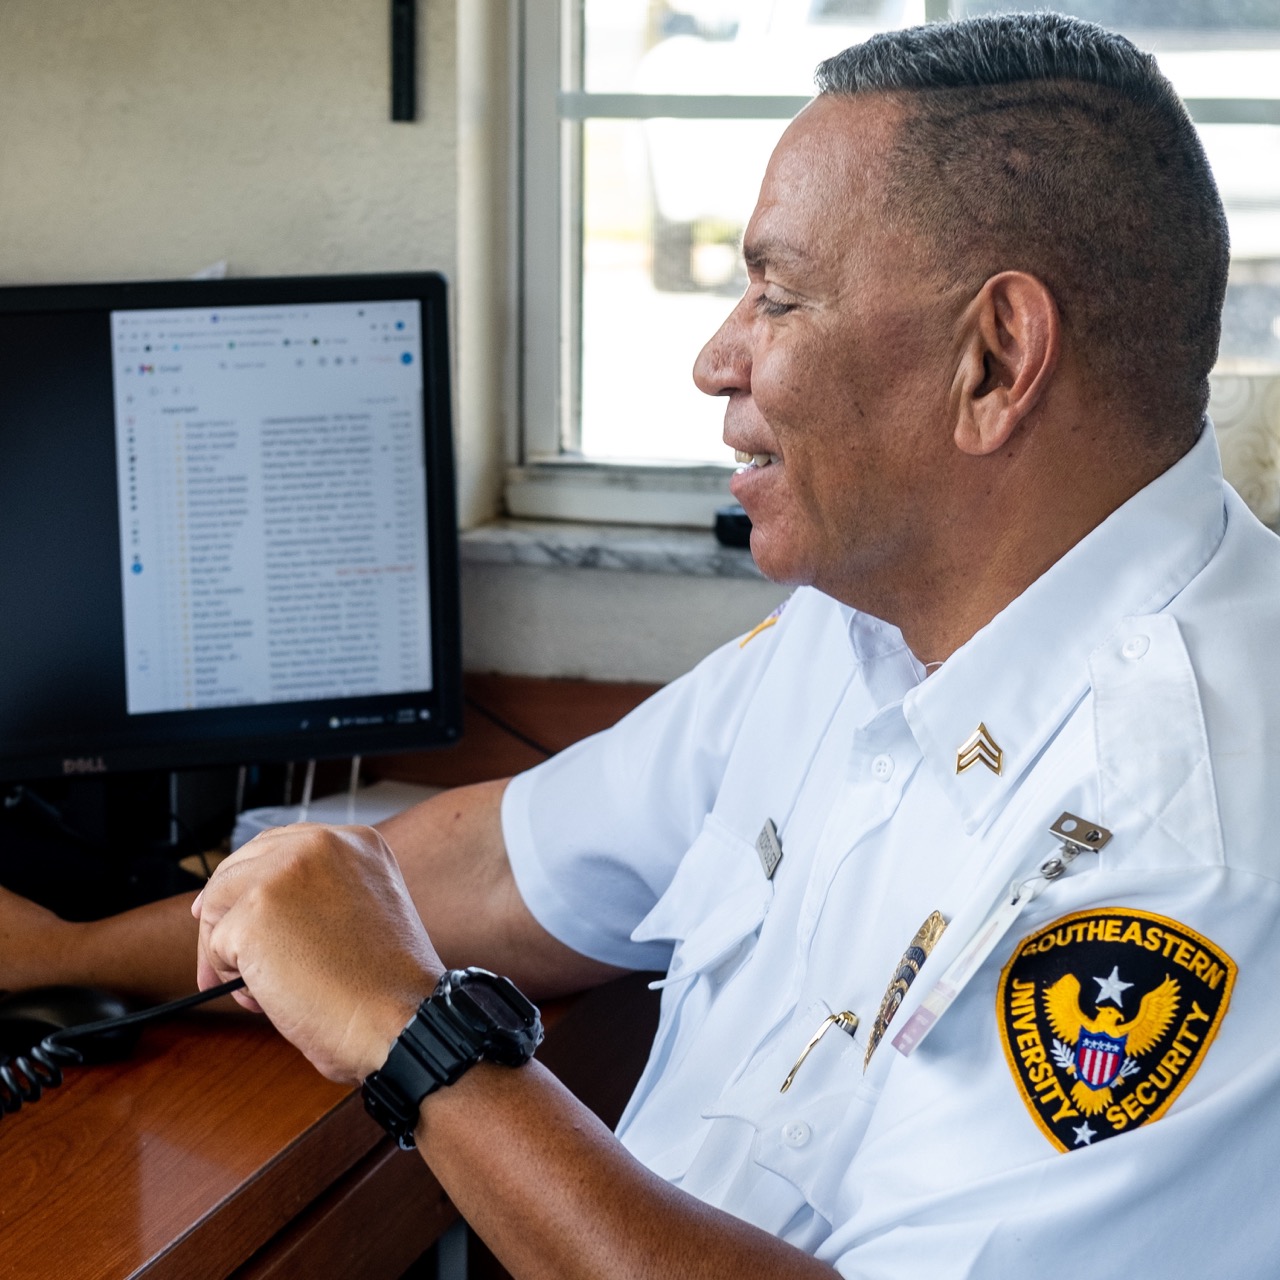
[0, 15, 1280, 1277]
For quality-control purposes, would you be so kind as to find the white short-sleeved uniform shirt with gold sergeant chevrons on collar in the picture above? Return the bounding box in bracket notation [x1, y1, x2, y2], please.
[503, 430, 1280, 1280]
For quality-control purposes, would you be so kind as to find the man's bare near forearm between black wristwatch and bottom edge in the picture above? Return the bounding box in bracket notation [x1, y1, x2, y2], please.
[416, 1062, 832, 1280]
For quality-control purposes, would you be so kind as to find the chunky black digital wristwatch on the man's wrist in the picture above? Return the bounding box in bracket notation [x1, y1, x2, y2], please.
[362, 969, 543, 1151]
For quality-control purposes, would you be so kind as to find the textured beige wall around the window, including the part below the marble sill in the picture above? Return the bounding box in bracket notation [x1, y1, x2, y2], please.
[0, 0, 782, 680]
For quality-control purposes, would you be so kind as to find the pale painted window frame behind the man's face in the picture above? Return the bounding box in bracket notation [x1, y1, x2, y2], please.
[504, 0, 1280, 529]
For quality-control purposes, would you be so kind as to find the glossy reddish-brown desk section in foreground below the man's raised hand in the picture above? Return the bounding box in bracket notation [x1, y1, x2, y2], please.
[0, 1015, 457, 1280]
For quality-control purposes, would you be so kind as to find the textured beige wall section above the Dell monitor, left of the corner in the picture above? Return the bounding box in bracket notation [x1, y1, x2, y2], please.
[0, 0, 457, 283]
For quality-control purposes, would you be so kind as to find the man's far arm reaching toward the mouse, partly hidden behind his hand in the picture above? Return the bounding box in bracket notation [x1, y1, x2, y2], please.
[0, 781, 620, 1001]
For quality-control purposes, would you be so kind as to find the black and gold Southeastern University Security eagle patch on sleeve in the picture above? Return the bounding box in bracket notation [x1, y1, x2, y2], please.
[996, 906, 1235, 1151]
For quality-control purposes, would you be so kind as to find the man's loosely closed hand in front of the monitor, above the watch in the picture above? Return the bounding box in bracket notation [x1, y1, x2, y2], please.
[192, 823, 444, 1083]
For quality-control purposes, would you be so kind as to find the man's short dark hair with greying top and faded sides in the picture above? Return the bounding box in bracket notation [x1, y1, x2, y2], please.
[817, 13, 1229, 452]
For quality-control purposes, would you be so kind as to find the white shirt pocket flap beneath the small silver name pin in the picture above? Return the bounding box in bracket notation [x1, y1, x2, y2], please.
[631, 814, 773, 987]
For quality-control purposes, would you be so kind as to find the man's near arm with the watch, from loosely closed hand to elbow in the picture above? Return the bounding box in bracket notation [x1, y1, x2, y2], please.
[189, 827, 831, 1280]
